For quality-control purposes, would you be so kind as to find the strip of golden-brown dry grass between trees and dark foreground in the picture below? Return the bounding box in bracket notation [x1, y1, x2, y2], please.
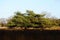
[0, 26, 60, 30]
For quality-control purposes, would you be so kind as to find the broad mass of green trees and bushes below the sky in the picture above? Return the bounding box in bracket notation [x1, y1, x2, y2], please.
[0, 10, 60, 28]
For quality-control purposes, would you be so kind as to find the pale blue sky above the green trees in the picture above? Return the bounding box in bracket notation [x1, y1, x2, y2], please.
[0, 0, 60, 18]
